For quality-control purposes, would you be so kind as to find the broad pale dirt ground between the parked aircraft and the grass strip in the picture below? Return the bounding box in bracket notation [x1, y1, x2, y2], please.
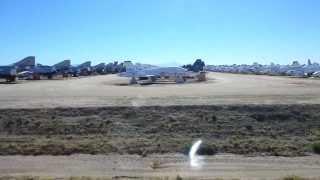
[0, 73, 320, 108]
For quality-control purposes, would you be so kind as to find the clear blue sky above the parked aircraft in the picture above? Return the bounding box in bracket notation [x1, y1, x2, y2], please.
[0, 0, 320, 65]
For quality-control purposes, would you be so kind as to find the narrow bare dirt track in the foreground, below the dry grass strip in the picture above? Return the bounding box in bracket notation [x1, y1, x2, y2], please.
[0, 154, 320, 179]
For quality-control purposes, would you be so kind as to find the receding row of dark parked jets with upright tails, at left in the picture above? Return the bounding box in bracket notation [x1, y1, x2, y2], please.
[0, 56, 124, 82]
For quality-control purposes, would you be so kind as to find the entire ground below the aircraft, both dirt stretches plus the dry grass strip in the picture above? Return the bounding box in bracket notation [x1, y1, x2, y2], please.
[0, 73, 320, 180]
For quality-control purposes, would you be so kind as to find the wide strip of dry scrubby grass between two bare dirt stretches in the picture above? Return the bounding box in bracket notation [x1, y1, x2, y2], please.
[0, 105, 320, 156]
